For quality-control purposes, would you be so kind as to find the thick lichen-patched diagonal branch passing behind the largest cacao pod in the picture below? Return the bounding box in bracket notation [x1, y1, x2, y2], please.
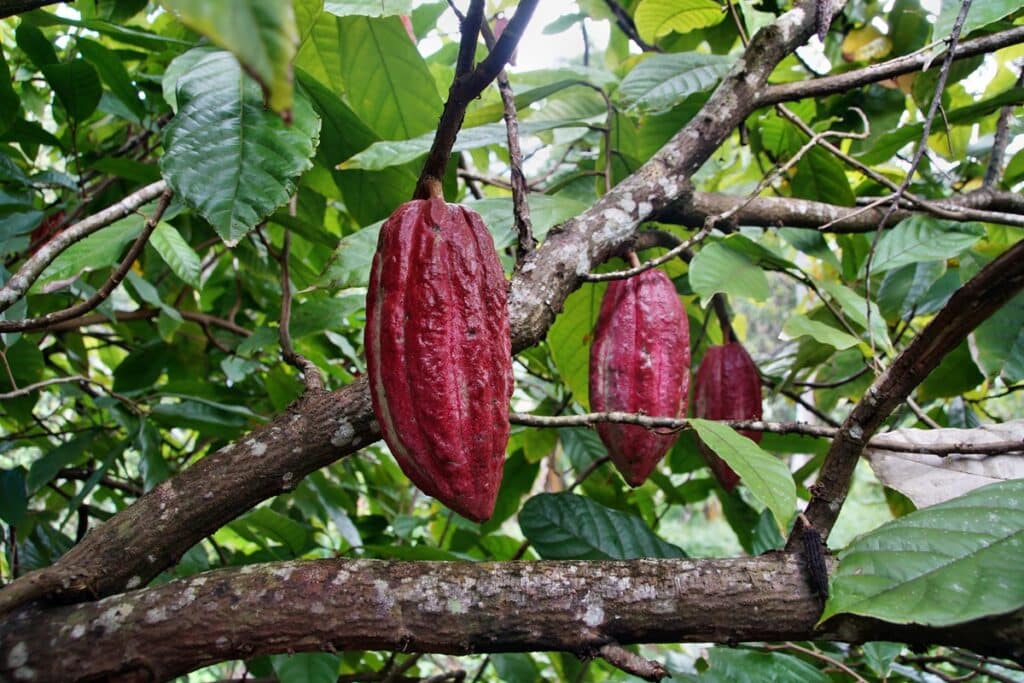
[0, 0, 842, 614]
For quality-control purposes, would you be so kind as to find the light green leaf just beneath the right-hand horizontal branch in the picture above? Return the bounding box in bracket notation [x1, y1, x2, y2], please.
[861, 214, 985, 274]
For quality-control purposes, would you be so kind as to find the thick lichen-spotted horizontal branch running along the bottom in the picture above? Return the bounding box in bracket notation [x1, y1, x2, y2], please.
[0, 554, 1024, 681]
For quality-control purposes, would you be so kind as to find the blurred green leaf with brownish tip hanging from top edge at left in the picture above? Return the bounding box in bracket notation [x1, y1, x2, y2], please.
[162, 0, 299, 112]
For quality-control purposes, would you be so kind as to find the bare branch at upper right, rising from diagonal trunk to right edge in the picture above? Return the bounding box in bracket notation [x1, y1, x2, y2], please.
[757, 27, 1024, 106]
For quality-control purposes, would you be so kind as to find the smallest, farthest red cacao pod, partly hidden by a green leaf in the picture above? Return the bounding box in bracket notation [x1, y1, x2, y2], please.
[693, 342, 761, 490]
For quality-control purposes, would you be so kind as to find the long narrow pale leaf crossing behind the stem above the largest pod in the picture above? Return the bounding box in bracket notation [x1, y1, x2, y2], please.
[340, 119, 586, 171]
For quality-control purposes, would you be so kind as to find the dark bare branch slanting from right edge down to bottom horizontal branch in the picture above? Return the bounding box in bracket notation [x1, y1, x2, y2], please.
[787, 237, 1024, 549]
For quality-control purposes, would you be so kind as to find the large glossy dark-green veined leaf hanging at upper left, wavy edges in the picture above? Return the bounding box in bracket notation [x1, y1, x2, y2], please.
[161, 51, 319, 246]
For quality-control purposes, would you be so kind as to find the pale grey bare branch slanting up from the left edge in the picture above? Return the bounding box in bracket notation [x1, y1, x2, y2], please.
[0, 180, 167, 311]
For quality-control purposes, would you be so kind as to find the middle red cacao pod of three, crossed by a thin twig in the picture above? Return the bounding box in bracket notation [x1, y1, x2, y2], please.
[590, 268, 690, 486]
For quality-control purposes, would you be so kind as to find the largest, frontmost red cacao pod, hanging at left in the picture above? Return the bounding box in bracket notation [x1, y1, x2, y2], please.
[366, 199, 512, 521]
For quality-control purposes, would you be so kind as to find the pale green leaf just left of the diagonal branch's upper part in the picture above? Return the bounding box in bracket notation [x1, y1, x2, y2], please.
[618, 52, 732, 112]
